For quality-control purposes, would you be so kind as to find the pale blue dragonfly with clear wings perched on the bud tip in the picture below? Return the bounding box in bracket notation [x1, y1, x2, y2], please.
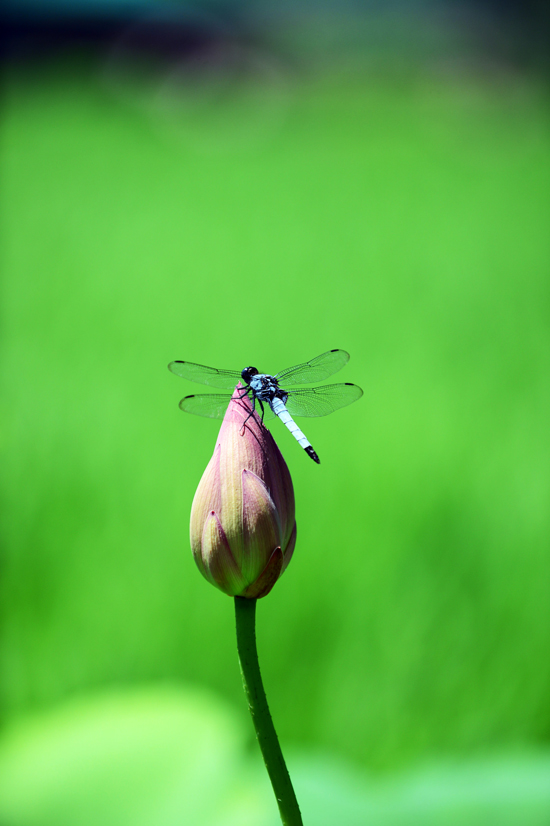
[168, 350, 363, 464]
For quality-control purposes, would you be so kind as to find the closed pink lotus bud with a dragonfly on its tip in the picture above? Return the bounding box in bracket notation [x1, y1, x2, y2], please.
[191, 383, 296, 599]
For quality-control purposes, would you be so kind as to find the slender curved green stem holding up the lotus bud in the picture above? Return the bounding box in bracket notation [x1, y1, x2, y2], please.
[235, 597, 303, 826]
